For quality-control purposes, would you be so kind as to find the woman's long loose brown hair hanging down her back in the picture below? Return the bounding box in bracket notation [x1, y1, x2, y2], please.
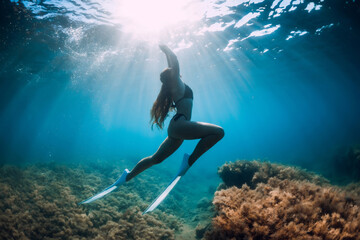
[150, 69, 174, 129]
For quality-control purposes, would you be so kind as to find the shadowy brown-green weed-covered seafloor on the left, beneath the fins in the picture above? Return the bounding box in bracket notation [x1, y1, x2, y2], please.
[0, 164, 181, 240]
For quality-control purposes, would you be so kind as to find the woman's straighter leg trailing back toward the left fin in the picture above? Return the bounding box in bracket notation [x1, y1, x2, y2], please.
[126, 137, 184, 181]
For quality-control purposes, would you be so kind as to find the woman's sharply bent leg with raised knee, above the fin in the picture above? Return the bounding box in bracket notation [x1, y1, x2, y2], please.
[168, 119, 225, 166]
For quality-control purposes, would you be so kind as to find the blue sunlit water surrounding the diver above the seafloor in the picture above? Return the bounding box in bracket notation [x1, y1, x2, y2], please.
[0, 0, 360, 179]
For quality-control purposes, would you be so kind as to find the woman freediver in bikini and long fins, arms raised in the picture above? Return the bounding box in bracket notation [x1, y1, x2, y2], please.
[80, 45, 224, 213]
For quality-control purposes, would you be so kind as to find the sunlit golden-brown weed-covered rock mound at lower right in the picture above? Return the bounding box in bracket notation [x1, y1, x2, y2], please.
[204, 161, 360, 240]
